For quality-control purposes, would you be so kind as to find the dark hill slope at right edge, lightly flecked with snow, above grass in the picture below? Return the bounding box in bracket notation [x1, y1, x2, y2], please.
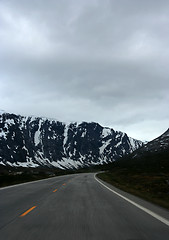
[116, 129, 169, 173]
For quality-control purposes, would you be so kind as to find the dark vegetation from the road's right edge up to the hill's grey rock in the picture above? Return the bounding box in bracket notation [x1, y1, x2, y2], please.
[97, 150, 169, 209]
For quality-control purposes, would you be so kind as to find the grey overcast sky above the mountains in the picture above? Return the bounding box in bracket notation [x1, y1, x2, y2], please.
[0, 0, 169, 140]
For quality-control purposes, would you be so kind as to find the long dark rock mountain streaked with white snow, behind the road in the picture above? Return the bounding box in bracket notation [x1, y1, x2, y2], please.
[0, 111, 143, 169]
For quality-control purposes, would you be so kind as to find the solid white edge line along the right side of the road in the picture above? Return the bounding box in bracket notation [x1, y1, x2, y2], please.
[94, 174, 169, 226]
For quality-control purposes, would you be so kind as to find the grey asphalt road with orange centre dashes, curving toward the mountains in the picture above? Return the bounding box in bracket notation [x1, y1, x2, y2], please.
[0, 173, 169, 240]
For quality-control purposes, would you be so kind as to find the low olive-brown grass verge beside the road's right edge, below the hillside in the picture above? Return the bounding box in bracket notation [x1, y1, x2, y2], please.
[97, 168, 169, 209]
